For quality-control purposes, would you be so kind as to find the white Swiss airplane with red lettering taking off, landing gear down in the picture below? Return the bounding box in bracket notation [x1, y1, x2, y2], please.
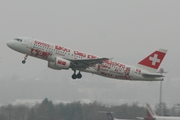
[6, 37, 167, 81]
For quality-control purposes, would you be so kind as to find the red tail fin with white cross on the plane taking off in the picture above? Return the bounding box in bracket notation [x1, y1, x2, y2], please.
[137, 49, 167, 73]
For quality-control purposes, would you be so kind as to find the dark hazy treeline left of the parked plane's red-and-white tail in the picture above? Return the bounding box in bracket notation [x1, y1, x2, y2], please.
[0, 98, 180, 120]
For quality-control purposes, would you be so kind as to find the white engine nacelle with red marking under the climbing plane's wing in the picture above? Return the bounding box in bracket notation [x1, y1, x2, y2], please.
[48, 57, 71, 70]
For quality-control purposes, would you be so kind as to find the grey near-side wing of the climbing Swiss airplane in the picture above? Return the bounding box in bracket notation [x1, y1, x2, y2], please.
[71, 58, 109, 69]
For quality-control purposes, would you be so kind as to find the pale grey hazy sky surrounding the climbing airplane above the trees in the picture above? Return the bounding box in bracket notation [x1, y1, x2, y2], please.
[0, 0, 180, 104]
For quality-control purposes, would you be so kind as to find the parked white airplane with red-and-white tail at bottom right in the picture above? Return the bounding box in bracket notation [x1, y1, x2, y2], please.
[137, 104, 180, 120]
